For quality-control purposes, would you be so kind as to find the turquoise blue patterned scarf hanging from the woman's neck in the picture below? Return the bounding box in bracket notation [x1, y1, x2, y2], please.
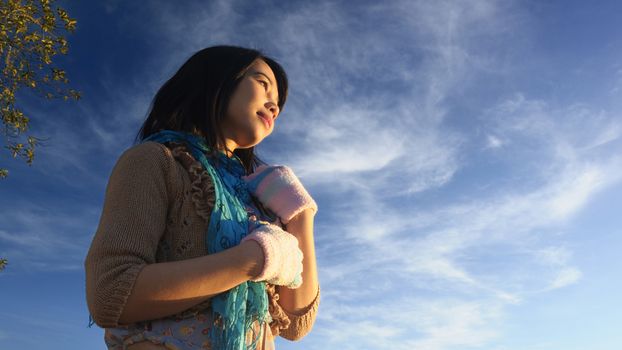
[89, 130, 272, 350]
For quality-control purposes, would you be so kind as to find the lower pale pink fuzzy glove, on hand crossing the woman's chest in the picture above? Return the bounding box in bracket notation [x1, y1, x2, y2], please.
[240, 223, 303, 289]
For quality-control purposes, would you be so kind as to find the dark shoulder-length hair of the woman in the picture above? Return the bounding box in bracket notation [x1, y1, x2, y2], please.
[135, 45, 288, 174]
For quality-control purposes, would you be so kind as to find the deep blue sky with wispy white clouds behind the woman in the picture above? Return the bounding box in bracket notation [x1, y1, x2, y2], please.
[0, 0, 622, 350]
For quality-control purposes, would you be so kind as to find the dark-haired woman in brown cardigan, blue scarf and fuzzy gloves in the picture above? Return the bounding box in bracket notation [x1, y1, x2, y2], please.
[85, 46, 320, 350]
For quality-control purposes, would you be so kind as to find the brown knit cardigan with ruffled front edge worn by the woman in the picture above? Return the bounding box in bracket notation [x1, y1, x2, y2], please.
[84, 142, 320, 340]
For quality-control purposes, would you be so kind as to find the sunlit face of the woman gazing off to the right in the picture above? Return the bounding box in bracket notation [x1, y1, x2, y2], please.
[223, 59, 279, 151]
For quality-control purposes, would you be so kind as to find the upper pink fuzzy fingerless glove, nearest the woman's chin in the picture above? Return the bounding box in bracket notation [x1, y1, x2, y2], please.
[242, 165, 317, 224]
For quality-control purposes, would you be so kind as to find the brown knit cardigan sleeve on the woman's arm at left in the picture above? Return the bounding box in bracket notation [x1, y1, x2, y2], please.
[84, 142, 175, 328]
